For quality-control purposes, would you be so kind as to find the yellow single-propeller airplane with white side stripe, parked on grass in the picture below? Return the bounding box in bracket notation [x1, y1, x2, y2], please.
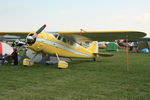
[0, 25, 146, 68]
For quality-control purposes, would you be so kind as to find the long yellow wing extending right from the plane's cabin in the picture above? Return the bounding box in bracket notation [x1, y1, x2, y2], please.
[58, 31, 146, 41]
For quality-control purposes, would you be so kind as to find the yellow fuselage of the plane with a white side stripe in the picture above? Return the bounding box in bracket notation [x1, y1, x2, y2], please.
[29, 32, 95, 58]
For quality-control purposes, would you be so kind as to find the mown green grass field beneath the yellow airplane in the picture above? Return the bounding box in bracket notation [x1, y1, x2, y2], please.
[0, 52, 150, 100]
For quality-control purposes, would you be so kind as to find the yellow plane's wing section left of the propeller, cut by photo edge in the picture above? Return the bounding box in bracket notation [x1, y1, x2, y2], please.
[0, 32, 30, 39]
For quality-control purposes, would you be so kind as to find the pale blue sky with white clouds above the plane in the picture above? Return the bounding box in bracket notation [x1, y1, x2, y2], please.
[0, 0, 150, 36]
